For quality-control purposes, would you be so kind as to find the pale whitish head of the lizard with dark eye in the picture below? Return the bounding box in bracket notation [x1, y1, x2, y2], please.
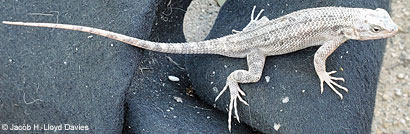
[346, 8, 398, 40]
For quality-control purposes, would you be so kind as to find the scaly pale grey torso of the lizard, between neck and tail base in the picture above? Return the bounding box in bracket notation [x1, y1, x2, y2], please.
[218, 7, 362, 55]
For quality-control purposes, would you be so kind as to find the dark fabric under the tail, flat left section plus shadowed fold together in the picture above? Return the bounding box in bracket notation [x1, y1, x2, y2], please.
[0, 0, 251, 133]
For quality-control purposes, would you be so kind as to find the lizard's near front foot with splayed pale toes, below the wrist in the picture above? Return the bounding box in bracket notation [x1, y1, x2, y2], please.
[318, 71, 348, 99]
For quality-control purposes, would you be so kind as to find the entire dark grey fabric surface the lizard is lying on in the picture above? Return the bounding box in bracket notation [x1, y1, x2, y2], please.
[0, 0, 389, 133]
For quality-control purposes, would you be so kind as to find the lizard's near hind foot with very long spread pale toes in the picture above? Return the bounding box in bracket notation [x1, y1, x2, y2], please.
[215, 77, 249, 132]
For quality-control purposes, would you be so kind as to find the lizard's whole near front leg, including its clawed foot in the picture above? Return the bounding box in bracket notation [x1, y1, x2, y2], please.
[314, 38, 348, 99]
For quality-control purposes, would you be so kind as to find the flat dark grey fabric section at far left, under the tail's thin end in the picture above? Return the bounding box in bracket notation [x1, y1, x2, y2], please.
[0, 0, 156, 133]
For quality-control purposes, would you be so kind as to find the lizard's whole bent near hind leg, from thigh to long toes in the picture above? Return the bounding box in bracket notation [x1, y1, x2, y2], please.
[215, 51, 265, 131]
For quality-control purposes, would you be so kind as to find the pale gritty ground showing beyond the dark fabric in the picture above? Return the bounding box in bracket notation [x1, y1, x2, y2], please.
[184, 0, 410, 134]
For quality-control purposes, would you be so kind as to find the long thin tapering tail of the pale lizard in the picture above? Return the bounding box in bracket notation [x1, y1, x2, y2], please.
[3, 21, 217, 54]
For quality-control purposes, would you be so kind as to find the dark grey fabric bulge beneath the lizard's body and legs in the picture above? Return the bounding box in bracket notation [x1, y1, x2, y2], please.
[186, 0, 389, 133]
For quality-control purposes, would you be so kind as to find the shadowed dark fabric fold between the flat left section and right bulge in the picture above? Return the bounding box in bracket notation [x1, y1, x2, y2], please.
[124, 1, 252, 134]
